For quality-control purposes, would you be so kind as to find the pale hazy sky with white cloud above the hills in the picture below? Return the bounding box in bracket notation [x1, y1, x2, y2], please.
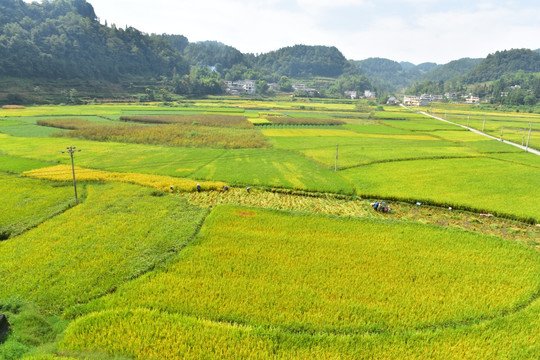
[40, 0, 540, 64]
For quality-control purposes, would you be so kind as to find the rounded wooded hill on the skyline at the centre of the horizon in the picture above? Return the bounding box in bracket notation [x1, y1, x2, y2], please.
[256, 45, 348, 78]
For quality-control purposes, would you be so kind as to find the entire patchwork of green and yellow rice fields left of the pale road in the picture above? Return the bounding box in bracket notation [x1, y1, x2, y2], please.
[0, 98, 540, 360]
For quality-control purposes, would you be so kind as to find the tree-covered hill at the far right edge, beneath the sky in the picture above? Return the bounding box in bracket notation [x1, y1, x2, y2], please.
[465, 49, 540, 84]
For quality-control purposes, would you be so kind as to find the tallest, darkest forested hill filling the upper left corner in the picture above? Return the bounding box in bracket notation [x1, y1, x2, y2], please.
[0, 0, 189, 80]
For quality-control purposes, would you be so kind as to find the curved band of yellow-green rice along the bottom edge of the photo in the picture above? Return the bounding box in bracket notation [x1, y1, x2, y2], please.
[60, 301, 540, 360]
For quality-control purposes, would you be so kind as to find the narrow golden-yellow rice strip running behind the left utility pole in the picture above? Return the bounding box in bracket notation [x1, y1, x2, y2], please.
[23, 165, 225, 192]
